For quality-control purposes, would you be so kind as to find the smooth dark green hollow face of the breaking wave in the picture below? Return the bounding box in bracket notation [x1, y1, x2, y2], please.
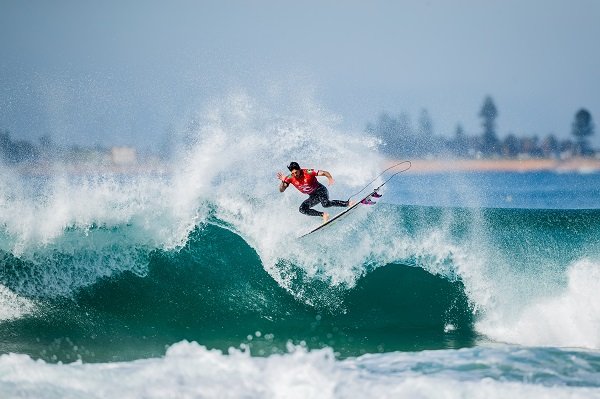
[0, 225, 473, 361]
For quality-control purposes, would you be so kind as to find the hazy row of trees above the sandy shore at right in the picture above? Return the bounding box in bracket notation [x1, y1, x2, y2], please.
[365, 96, 596, 158]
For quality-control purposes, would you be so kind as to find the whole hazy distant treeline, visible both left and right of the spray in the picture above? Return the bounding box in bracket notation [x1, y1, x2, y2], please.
[0, 96, 596, 164]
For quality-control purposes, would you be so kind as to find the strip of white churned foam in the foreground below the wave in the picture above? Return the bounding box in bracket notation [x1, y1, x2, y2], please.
[0, 342, 600, 399]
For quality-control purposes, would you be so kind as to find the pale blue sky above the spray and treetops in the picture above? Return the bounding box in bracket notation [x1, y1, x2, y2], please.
[0, 0, 600, 146]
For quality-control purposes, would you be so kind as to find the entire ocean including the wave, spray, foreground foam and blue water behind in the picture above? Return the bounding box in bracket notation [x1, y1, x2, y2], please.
[0, 103, 600, 398]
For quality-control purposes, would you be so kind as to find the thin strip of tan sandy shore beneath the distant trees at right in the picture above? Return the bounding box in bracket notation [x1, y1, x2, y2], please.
[389, 158, 600, 173]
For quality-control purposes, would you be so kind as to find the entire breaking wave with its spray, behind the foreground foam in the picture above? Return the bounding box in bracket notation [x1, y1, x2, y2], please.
[0, 95, 600, 361]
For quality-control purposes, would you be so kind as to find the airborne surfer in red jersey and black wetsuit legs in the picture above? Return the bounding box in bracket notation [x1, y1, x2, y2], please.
[277, 162, 352, 223]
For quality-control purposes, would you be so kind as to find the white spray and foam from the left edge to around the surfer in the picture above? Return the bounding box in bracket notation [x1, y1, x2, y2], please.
[0, 93, 380, 310]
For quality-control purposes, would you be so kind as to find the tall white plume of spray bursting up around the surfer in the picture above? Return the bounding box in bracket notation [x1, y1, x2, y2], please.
[170, 93, 382, 291]
